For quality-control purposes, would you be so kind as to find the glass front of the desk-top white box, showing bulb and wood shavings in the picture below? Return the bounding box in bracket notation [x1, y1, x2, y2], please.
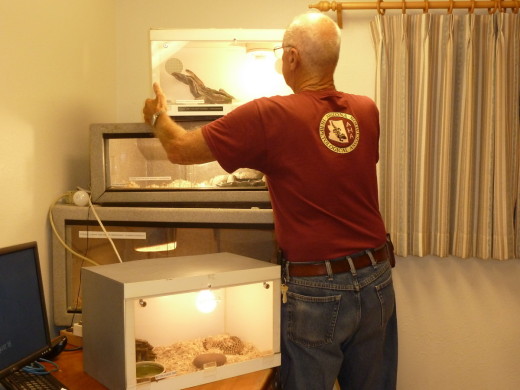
[134, 281, 274, 382]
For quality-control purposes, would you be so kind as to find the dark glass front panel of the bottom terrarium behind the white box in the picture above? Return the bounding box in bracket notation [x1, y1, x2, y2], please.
[66, 222, 276, 313]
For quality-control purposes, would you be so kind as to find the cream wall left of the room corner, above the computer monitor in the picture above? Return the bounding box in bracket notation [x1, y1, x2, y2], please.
[0, 0, 116, 318]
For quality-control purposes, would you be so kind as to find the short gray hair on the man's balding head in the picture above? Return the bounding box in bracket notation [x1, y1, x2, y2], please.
[283, 12, 341, 72]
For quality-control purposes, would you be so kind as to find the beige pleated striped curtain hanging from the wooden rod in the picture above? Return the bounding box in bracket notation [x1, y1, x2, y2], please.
[371, 13, 520, 259]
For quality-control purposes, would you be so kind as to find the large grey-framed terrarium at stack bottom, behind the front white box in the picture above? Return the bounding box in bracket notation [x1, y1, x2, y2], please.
[52, 205, 276, 326]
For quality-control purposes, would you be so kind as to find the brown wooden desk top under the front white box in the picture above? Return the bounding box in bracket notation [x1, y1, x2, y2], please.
[45, 350, 274, 390]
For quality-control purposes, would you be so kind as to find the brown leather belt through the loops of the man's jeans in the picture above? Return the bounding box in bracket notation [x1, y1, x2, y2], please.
[287, 244, 389, 276]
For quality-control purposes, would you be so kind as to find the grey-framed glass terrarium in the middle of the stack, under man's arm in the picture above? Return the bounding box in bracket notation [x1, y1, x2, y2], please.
[90, 121, 269, 207]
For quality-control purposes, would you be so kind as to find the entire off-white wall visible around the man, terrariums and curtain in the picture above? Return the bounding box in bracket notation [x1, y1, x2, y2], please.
[0, 0, 520, 390]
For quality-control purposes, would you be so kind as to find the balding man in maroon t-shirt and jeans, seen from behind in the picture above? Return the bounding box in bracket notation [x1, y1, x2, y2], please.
[143, 13, 397, 390]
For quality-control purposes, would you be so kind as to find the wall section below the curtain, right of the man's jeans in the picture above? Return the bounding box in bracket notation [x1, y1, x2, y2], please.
[394, 256, 520, 390]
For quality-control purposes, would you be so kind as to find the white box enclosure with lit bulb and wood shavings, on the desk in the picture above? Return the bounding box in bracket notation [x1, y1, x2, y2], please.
[82, 253, 281, 390]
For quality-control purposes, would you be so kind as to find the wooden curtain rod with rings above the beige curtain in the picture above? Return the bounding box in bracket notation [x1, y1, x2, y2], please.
[309, 0, 520, 28]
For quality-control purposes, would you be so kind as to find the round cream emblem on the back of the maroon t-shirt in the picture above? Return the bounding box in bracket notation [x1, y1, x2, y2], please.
[320, 112, 359, 153]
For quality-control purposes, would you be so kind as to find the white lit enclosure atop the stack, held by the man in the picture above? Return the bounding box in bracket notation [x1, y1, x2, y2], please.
[150, 29, 292, 120]
